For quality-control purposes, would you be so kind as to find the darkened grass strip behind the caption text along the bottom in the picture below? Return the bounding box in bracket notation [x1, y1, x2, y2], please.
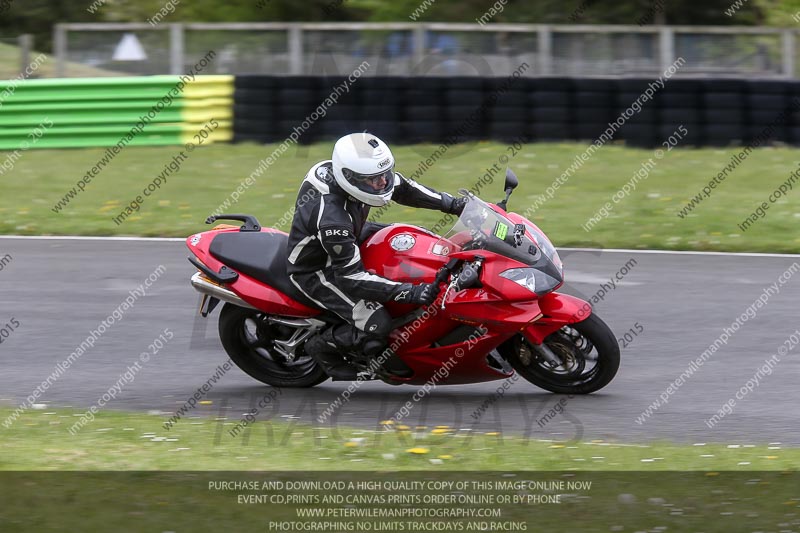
[0, 470, 800, 533]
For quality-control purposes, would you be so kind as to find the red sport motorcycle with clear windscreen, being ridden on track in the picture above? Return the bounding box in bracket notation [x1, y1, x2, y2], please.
[186, 169, 620, 394]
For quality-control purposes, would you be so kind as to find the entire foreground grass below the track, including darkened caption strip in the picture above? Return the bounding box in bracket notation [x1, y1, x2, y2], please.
[0, 406, 800, 533]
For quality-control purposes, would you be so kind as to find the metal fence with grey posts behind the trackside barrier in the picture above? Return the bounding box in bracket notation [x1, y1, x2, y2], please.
[32, 23, 799, 78]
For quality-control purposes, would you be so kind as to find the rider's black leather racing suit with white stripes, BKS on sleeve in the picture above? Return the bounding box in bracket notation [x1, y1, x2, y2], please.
[287, 160, 459, 364]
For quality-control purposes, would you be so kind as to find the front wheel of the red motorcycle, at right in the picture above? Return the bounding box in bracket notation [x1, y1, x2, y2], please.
[499, 314, 619, 394]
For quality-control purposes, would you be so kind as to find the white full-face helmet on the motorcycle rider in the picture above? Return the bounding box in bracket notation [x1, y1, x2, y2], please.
[331, 133, 394, 207]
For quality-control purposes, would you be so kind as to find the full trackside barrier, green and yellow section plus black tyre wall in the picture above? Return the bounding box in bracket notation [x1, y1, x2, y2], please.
[0, 76, 800, 150]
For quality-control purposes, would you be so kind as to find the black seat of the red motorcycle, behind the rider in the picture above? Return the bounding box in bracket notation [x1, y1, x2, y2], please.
[209, 232, 317, 309]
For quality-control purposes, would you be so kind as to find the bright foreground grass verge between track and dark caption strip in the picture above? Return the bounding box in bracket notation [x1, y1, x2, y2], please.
[0, 408, 800, 471]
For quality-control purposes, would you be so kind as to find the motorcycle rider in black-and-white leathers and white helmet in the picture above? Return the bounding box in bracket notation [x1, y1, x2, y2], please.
[288, 133, 466, 380]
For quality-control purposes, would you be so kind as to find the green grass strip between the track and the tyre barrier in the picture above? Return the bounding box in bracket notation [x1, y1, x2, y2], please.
[0, 142, 800, 252]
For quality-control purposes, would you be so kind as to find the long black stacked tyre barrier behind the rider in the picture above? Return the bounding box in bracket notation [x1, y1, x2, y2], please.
[234, 76, 800, 147]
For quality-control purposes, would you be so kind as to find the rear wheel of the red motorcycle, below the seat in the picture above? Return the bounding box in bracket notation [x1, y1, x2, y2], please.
[219, 303, 328, 387]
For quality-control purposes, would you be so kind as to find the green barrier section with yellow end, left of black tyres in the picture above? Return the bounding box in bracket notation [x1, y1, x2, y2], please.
[0, 76, 233, 150]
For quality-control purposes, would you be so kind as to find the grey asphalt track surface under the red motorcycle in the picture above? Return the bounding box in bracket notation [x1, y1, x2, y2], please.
[0, 237, 800, 446]
